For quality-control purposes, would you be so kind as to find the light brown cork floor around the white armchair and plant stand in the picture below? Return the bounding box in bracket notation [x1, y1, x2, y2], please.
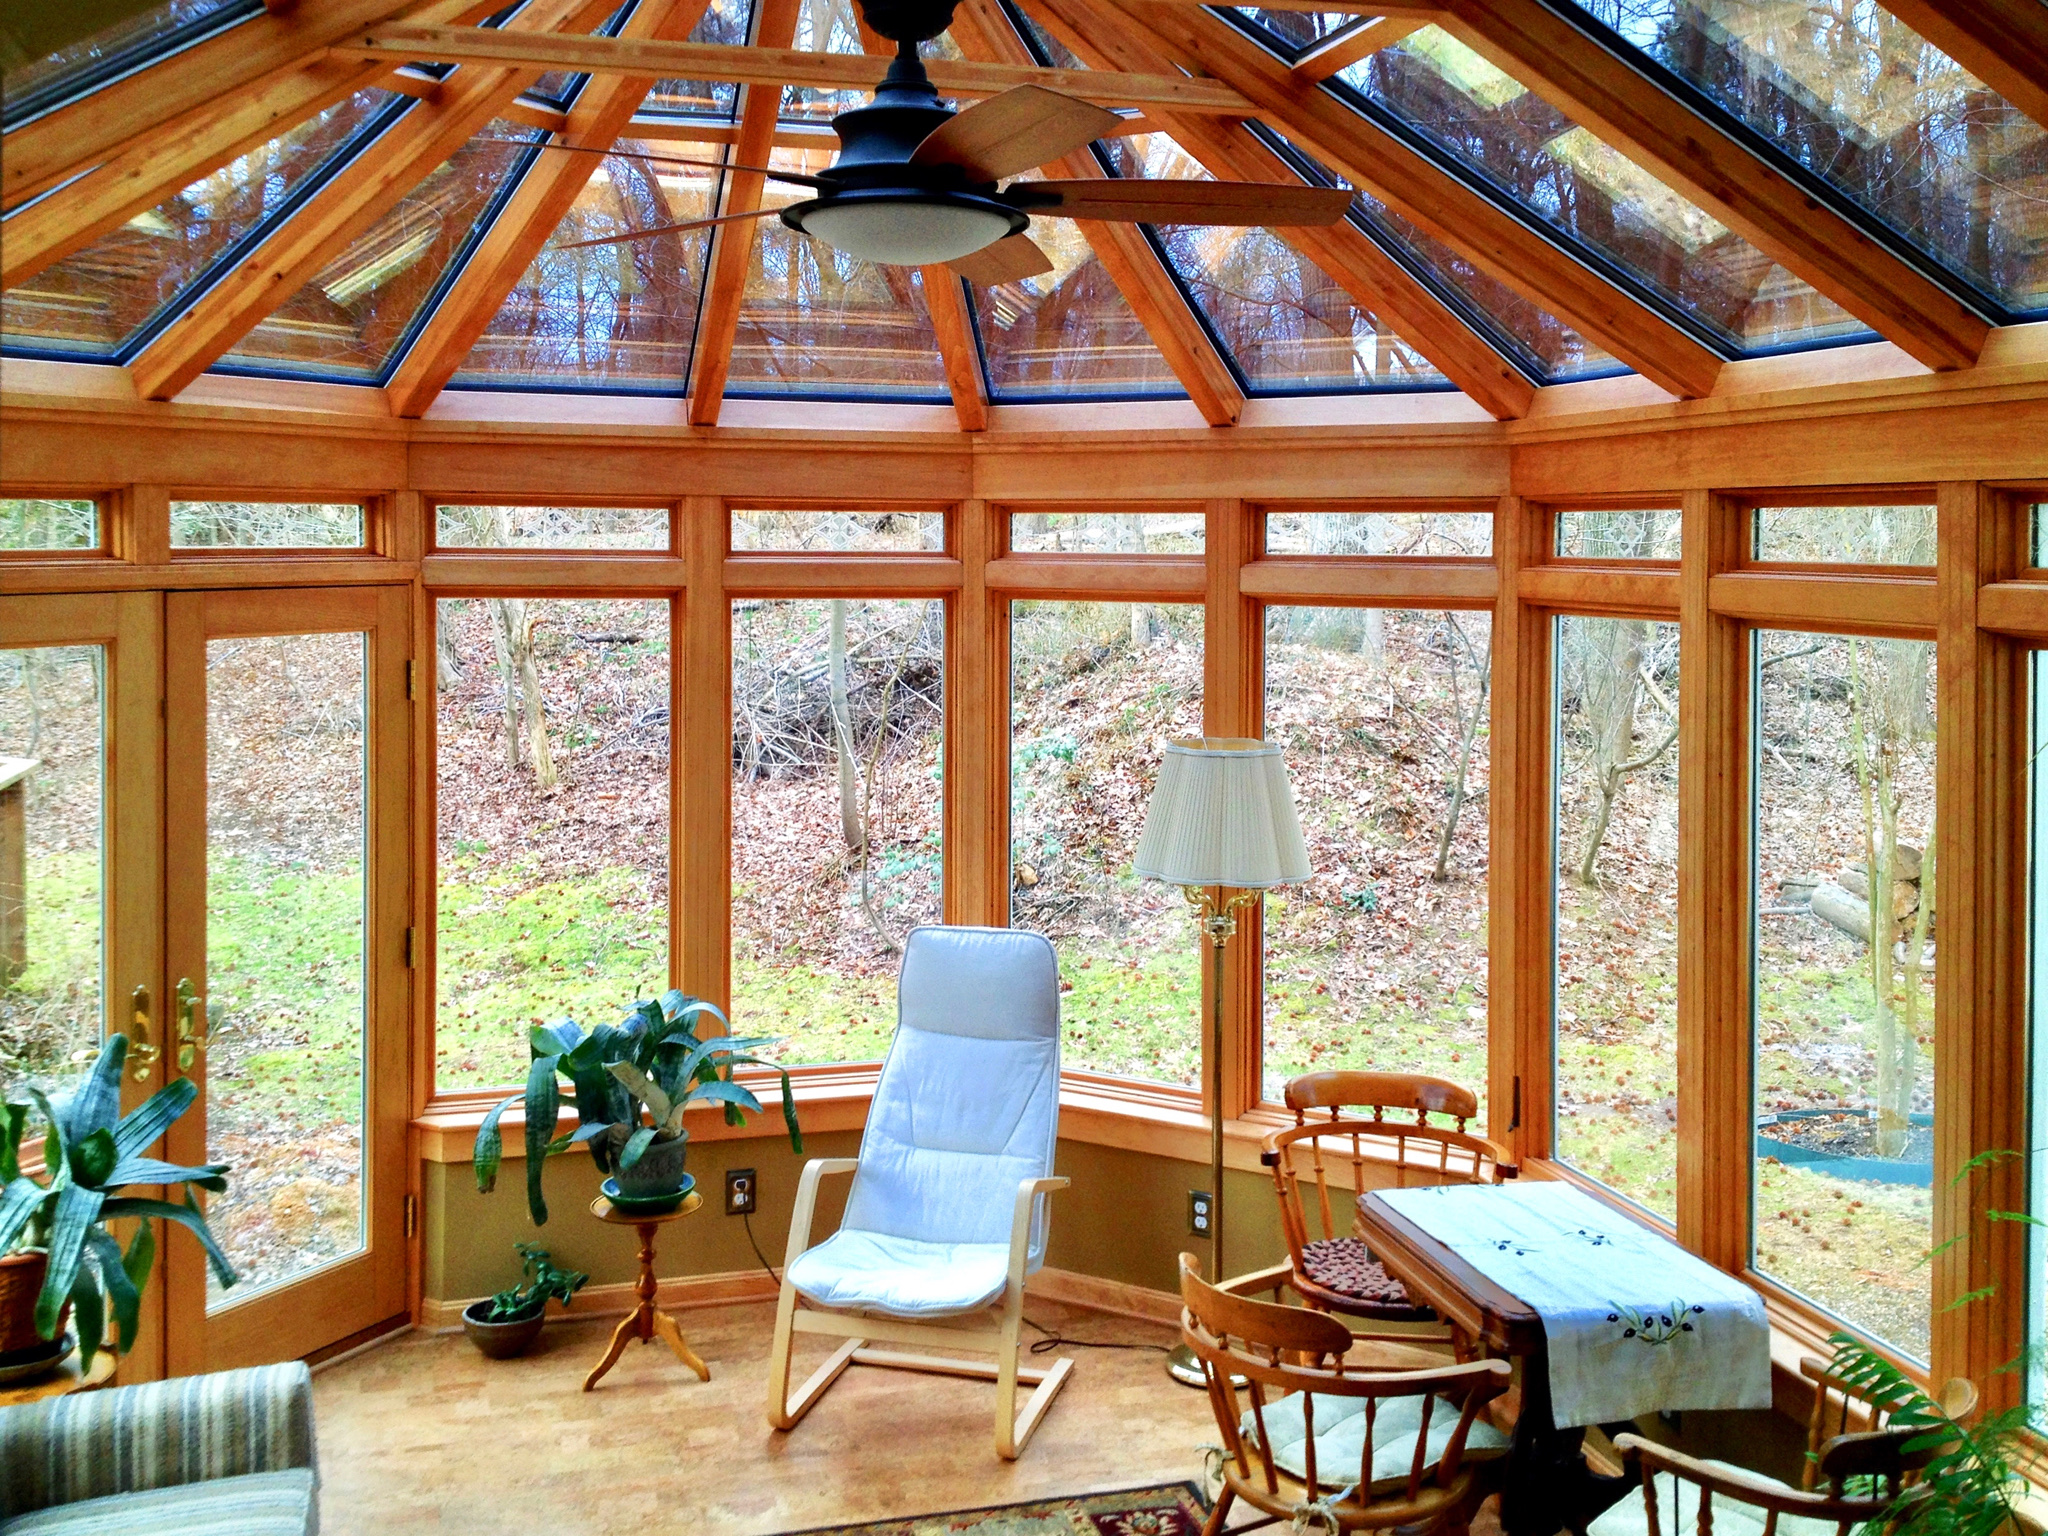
[313, 1300, 1217, 1536]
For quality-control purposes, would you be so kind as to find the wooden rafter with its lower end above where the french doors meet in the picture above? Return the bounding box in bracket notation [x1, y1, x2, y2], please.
[129, 0, 614, 399]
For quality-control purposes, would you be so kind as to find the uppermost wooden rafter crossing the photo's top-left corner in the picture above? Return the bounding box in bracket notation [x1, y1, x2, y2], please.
[0, 0, 446, 207]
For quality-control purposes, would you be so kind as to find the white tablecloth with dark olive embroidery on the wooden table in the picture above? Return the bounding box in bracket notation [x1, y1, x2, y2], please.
[1378, 1184, 1772, 1427]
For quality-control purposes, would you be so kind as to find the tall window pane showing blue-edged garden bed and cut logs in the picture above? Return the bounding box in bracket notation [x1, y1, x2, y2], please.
[1753, 633, 1950, 1360]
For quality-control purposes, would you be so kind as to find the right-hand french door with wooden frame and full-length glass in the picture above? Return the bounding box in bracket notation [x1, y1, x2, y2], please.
[156, 588, 412, 1376]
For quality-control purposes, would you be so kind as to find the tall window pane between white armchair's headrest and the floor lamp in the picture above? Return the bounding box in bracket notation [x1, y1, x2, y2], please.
[1010, 602, 1202, 1087]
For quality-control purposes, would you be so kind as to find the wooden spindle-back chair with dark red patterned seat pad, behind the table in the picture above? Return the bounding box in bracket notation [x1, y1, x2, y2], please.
[1260, 1071, 1516, 1323]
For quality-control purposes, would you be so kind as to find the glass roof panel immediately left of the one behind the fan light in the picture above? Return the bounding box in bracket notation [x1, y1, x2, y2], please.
[453, 139, 719, 395]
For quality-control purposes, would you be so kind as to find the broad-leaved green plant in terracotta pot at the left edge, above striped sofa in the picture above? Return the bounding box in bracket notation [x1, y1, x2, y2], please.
[0, 1034, 236, 1366]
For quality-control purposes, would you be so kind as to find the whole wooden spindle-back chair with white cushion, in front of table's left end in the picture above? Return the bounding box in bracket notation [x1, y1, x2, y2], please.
[1180, 1253, 1511, 1536]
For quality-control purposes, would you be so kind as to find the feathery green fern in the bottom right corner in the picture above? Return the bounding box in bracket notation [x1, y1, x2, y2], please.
[1829, 1149, 2048, 1536]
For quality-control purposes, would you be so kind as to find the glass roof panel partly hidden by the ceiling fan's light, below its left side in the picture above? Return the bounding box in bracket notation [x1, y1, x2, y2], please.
[725, 150, 950, 399]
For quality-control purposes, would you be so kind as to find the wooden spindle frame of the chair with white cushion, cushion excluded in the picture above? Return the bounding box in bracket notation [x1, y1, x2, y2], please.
[1180, 1253, 1511, 1536]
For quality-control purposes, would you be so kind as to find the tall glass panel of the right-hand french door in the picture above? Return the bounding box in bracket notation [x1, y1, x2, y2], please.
[203, 633, 367, 1311]
